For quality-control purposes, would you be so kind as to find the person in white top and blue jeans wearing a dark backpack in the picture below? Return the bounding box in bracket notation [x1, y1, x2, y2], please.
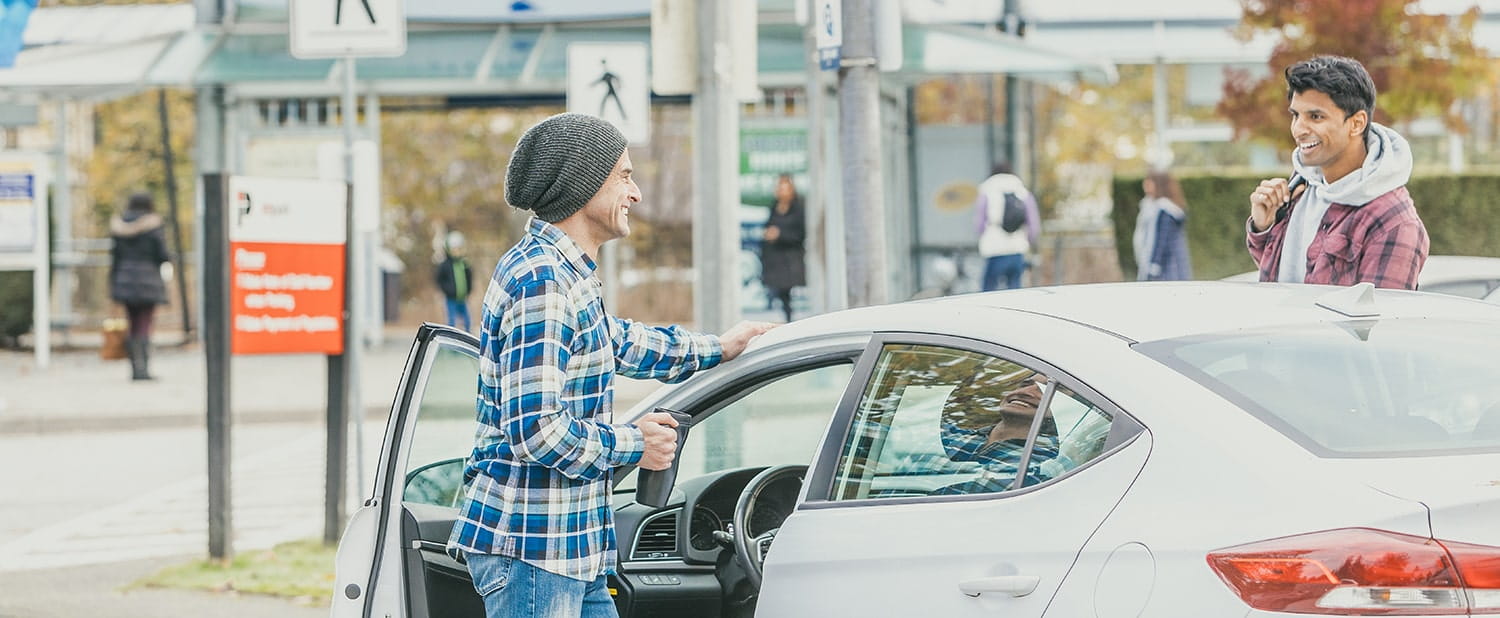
[974, 164, 1041, 291]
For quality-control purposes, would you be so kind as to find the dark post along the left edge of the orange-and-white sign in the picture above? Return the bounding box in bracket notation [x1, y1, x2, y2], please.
[200, 173, 234, 560]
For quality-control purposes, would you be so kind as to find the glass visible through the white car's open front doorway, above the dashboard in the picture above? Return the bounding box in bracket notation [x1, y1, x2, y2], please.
[615, 363, 854, 491]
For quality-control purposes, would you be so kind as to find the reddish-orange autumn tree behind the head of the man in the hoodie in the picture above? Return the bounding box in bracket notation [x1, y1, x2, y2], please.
[1218, 0, 1491, 141]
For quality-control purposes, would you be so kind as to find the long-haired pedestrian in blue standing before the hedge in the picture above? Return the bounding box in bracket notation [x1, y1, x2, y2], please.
[1131, 171, 1193, 281]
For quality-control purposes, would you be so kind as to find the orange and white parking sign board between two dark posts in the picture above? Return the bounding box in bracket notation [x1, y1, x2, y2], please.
[230, 176, 345, 354]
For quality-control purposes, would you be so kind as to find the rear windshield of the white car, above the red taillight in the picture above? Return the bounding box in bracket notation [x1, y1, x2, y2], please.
[1137, 318, 1500, 458]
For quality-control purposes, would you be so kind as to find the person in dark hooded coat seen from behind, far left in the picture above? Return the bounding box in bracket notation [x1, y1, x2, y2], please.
[110, 194, 168, 380]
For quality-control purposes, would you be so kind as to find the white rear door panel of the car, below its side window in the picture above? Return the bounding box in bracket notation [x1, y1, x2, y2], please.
[758, 432, 1151, 617]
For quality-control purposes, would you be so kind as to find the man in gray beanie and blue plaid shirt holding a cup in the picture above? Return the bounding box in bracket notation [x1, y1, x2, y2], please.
[449, 114, 771, 618]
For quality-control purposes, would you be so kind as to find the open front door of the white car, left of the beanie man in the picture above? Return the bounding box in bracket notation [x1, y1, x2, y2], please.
[330, 324, 485, 618]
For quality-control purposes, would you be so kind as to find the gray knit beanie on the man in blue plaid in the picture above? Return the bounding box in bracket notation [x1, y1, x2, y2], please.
[506, 114, 626, 224]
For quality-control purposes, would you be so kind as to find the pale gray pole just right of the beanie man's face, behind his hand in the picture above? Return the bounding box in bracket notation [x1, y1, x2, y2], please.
[693, 0, 747, 333]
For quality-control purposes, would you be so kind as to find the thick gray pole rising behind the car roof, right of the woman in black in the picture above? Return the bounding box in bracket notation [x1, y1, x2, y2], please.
[839, 0, 888, 308]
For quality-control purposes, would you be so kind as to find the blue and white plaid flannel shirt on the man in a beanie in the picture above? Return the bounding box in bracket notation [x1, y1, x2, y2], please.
[447, 219, 723, 581]
